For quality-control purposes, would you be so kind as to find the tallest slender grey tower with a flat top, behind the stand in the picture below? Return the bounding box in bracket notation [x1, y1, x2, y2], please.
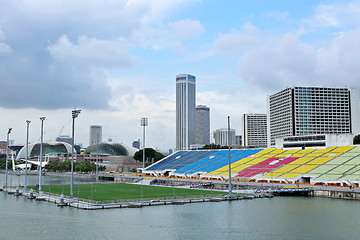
[176, 74, 196, 150]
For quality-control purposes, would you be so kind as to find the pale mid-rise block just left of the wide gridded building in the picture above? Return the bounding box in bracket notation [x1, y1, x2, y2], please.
[242, 113, 268, 148]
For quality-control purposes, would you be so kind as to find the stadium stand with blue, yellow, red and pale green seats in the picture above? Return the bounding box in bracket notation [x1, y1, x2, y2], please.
[145, 146, 360, 184]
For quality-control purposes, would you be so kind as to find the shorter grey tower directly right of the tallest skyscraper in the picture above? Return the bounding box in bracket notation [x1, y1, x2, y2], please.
[195, 105, 210, 146]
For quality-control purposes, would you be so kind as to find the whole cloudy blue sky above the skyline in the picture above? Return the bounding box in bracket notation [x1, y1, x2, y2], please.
[0, 0, 360, 151]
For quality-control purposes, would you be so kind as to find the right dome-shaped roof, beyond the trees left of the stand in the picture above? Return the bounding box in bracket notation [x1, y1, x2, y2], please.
[85, 142, 137, 157]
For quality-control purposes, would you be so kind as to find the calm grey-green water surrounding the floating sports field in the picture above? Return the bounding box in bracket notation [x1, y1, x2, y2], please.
[0, 175, 360, 240]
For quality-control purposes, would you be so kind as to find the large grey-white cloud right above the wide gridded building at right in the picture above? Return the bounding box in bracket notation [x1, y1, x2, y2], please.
[239, 29, 360, 93]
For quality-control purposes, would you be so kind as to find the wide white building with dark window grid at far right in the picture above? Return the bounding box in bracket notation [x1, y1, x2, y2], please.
[268, 87, 360, 147]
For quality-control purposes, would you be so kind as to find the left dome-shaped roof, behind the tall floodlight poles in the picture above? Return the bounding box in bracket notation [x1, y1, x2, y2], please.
[16, 142, 72, 160]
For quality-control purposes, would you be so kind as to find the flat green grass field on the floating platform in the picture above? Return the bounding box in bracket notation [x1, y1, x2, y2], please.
[29, 183, 226, 202]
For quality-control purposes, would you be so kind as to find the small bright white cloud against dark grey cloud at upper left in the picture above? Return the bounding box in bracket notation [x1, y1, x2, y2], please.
[48, 35, 132, 67]
